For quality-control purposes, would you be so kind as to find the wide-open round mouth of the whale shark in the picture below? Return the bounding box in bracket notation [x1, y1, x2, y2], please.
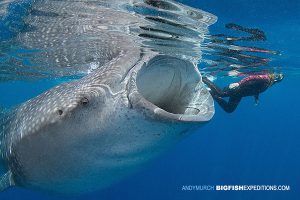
[131, 56, 214, 121]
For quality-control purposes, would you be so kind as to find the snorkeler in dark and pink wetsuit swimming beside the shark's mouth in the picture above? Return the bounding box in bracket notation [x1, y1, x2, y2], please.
[202, 73, 283, 113]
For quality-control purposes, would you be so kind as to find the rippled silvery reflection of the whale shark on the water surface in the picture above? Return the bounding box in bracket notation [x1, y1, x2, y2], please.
[0, 0, 216, 80]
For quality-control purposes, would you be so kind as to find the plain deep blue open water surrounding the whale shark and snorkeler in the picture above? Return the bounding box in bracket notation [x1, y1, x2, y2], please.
[0, 0, 300, 200]
